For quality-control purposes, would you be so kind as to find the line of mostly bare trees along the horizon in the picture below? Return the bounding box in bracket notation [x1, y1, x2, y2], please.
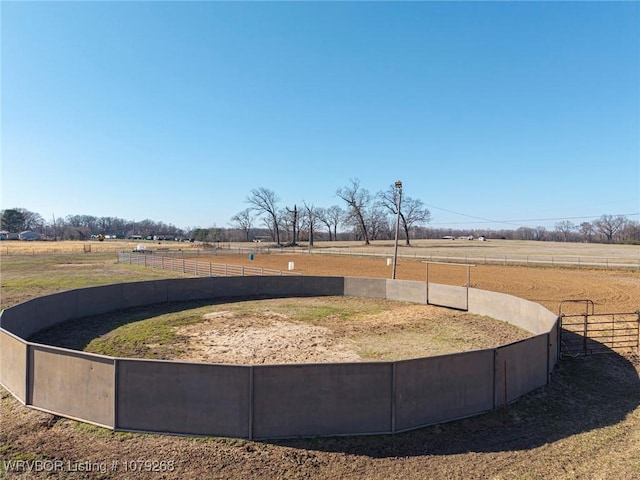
[0, 179, 640, 246]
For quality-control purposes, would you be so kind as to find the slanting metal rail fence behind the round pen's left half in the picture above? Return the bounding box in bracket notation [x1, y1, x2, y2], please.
[118, 252, 302, 277]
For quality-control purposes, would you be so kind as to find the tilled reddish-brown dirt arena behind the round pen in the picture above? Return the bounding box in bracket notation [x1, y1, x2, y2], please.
[206, 254, 640, 313]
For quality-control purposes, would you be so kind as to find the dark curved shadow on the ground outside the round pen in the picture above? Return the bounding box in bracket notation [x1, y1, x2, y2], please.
[271, 353, 640, 458]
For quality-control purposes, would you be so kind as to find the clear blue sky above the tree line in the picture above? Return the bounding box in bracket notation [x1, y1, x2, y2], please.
[0, 1, 640, 229]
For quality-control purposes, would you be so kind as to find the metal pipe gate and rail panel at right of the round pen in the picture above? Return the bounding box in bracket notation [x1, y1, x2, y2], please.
[559, 300, 640, 356]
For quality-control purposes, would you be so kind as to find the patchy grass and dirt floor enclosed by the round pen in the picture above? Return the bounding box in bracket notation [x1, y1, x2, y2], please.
[31, 297, 530, 364]
